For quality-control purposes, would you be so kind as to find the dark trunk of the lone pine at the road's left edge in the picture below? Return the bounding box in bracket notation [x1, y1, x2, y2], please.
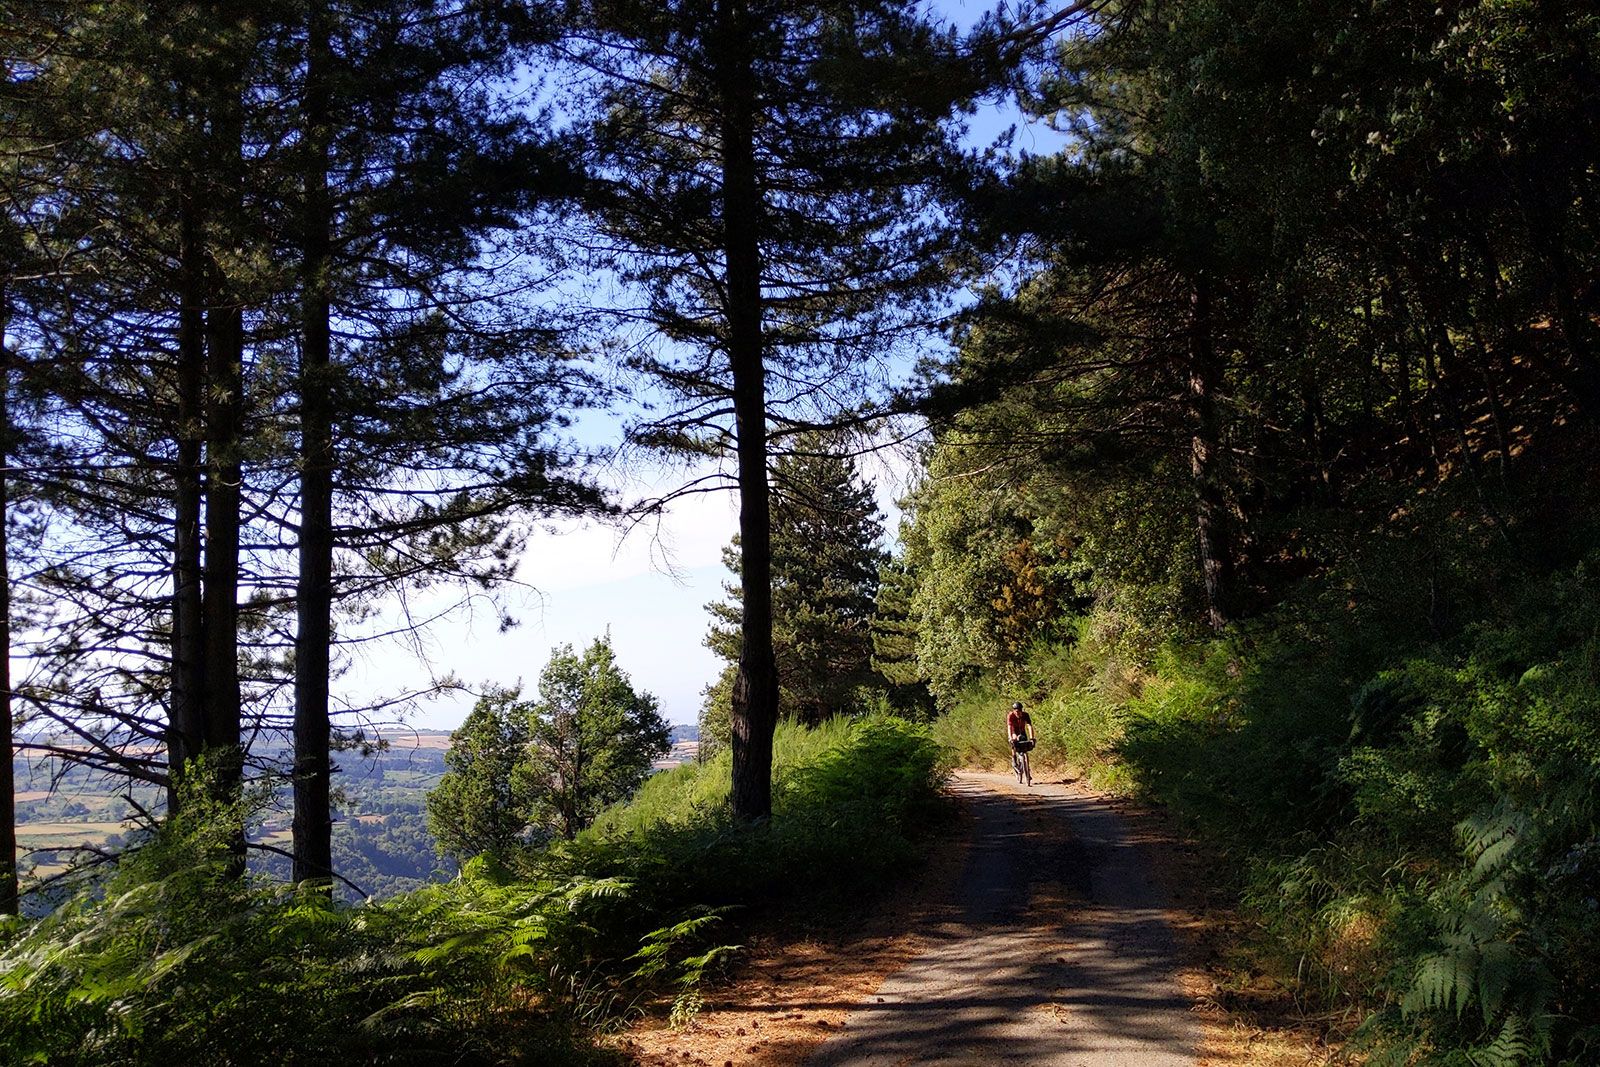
[717, 0, 778, 819]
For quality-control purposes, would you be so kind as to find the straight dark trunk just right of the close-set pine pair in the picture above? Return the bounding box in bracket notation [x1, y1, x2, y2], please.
[293, 2, 333, 891]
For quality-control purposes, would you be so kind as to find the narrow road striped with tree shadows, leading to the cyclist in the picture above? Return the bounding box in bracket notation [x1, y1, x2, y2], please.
[806, 773, 1200, 1067]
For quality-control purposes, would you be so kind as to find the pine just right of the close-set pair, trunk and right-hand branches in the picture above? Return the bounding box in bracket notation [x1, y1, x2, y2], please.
[290, 0, 600, 881]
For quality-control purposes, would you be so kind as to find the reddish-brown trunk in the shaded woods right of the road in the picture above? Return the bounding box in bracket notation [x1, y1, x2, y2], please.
[1189, 278, 1235, 630]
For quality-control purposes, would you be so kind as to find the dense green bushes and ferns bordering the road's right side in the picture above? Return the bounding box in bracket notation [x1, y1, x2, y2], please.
[934, 563, 1600, 1064]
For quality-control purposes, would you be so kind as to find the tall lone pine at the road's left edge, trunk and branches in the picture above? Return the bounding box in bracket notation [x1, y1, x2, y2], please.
[565, 0, 963, 817]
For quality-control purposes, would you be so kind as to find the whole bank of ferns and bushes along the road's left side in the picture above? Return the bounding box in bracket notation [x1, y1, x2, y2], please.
[0, 718, 942, 1067]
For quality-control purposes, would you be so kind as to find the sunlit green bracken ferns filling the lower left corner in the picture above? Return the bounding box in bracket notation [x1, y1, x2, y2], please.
[0, 780, 617, 1065]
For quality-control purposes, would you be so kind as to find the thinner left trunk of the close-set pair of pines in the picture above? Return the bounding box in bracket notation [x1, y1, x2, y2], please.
[166, 182, 206, 811]
